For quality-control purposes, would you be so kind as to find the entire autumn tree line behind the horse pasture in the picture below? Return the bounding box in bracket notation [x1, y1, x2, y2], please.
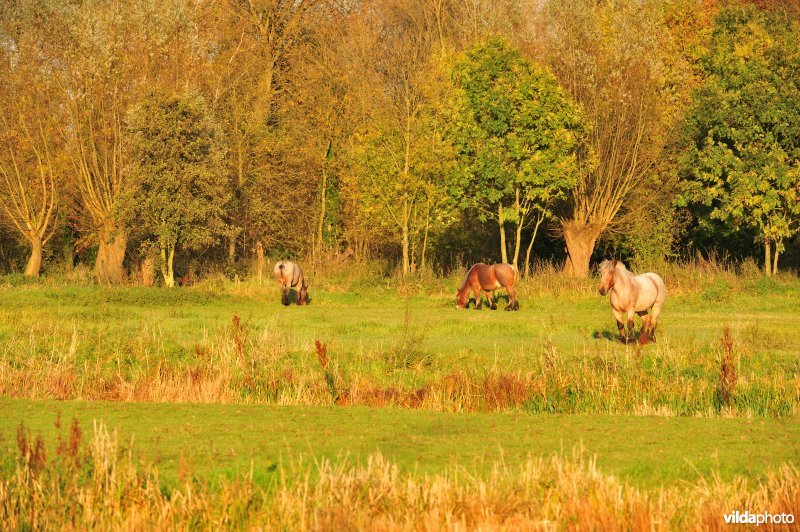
[0, 0, 800, 286]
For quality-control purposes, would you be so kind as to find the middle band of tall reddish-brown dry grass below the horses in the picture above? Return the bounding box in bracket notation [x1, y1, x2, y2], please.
[0, 316, 800, 416]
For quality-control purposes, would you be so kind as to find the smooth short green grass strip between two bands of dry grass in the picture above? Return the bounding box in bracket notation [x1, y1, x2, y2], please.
[0, 398, 800, 486]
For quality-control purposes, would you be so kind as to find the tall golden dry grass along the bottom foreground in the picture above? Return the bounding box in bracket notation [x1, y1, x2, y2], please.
[0, 425, 800, 530]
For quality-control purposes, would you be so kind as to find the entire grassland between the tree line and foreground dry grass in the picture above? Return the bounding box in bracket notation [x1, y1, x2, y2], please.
[0, 269, 800, 528]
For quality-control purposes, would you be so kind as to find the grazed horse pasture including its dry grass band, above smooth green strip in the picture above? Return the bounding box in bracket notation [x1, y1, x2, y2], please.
[0, 268, 800, 416]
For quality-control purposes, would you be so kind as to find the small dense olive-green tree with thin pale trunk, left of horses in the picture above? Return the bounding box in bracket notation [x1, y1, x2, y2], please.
[125, 93, 228, 287]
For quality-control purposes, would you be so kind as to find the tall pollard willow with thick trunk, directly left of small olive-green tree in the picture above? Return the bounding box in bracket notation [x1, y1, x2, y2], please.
[61, 0, 214, 282]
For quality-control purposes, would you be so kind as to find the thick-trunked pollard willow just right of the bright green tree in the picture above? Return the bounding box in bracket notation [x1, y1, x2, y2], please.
[535, 0, 675, 277]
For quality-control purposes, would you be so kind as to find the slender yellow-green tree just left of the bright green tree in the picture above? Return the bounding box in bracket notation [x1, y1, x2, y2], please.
[348, 1, 450, 275]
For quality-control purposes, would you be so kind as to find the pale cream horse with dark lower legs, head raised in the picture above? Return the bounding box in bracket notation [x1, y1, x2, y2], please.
[597, 260, 667, 343]
